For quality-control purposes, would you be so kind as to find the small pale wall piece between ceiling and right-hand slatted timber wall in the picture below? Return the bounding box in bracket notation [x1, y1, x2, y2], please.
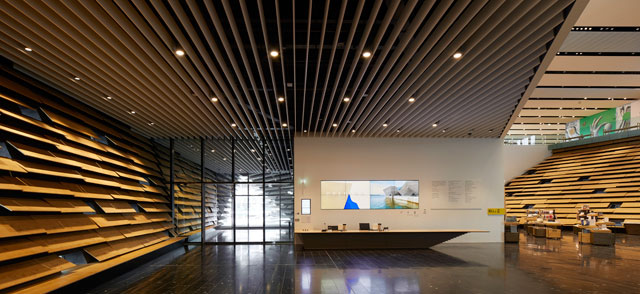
[503, 145, 551, 182]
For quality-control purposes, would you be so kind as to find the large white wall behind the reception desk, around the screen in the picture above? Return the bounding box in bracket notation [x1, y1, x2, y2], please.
[294, 137, 504, 242]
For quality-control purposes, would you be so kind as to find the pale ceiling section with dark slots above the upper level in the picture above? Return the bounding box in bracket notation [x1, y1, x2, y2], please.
[505, 0, 640, 143]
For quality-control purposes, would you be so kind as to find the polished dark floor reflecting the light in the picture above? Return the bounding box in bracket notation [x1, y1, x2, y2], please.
[89, 232, 640, 294]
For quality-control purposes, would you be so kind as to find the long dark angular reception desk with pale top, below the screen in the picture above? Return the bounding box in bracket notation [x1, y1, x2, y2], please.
[295, 230, 488, 249]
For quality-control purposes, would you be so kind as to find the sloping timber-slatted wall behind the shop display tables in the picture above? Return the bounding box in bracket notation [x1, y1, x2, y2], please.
[505, 137, 640, 225]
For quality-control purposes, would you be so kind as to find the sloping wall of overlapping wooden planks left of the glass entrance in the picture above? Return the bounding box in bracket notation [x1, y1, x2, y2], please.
[0, 68, 173, 290]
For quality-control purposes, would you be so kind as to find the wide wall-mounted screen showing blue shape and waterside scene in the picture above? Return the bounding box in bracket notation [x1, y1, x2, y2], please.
[320, 181, 420, 209]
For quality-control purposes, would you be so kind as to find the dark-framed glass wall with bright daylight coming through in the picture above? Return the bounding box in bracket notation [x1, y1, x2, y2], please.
[157, 139, 293, 243]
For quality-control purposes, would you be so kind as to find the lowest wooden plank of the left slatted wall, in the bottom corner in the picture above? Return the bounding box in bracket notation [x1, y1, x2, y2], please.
[0, 255, 75, 289]
